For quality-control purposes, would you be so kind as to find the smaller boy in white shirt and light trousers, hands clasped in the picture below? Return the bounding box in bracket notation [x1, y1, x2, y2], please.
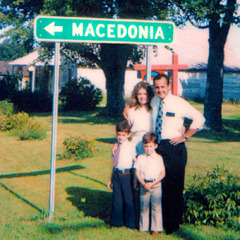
[134, 133, 165, 235]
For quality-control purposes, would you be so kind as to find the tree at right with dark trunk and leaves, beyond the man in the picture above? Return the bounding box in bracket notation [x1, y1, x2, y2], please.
[171, 0, 240, 131]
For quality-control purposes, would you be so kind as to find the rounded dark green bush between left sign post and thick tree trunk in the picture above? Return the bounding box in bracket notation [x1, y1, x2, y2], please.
[60, 78, 103, 111]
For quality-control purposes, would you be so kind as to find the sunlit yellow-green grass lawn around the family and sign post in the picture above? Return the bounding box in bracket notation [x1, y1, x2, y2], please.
[0, 103, 240, 240]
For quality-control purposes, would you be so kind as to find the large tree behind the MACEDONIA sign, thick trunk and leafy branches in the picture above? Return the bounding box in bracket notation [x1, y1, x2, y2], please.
[0, 0, 168, 116]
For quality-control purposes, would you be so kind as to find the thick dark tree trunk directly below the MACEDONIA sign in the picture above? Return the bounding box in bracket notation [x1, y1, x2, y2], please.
[100, 44, 132, 117]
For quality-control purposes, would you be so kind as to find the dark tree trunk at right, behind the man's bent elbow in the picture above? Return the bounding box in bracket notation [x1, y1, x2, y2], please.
[204, 0, 236, 132]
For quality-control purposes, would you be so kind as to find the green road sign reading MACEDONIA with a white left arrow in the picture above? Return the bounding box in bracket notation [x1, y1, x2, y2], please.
[34, 16, 174, 44]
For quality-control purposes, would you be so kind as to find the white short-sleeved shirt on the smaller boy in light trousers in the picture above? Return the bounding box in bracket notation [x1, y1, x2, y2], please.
[134, 151, 165, 180]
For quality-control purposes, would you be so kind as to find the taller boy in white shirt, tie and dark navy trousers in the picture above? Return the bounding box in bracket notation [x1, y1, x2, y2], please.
[108, 121, 136, 228]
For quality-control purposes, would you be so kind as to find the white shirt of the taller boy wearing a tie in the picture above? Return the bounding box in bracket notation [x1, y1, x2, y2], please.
[113, 140, 136, 170]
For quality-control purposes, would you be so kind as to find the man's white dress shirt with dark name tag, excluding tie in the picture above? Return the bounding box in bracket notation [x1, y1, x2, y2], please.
[151, 93, 205, 139]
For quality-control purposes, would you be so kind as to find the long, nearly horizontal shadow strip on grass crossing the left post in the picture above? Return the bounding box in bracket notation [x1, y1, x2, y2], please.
[0, 165, 85, 179]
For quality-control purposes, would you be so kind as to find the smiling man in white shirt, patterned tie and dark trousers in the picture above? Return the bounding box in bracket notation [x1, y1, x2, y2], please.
[151, 74, 205, 234]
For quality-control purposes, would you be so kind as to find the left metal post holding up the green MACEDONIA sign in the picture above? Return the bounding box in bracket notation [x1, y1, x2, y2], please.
[49, 42, 60, 221]
